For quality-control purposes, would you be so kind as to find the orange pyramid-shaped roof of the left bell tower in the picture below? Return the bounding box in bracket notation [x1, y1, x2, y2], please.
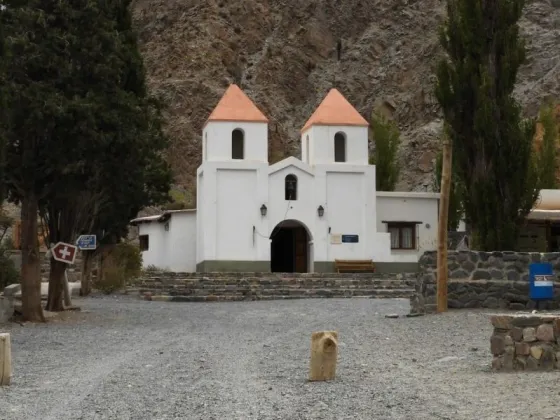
[206, 84, 268, 123]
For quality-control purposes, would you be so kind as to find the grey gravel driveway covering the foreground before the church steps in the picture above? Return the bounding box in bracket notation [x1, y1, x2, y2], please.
[0, 297, 560, 420]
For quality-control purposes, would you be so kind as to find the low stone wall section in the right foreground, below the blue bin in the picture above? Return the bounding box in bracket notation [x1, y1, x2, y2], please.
[490, 314, 560, 371]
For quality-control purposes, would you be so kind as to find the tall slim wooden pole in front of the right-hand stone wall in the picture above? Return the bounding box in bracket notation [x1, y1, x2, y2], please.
[437, 135, 452, 312]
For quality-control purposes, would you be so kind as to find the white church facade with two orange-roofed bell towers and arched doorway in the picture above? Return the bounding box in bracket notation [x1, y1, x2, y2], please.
[196, 85, 390, 272]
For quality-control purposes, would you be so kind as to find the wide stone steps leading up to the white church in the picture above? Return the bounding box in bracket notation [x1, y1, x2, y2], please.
[132, 272, 416, 302]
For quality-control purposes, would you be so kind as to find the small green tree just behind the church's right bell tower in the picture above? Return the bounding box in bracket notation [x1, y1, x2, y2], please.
[370, 112, 400, 191]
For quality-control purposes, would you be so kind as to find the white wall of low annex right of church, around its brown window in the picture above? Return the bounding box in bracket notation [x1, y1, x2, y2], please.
[377, 191, 439, 262]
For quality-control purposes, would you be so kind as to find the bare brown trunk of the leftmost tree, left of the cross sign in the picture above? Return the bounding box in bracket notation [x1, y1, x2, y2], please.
[21, 194, 45, 322]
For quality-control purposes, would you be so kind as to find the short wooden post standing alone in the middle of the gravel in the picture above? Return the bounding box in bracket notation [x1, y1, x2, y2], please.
[309, 331, 338, 381]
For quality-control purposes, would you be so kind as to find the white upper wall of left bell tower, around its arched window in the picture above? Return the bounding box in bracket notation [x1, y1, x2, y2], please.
[202, 121, 268, 162]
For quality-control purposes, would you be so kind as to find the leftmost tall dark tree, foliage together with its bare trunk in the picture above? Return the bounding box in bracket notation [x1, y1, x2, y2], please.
[0, 0, 86, 321]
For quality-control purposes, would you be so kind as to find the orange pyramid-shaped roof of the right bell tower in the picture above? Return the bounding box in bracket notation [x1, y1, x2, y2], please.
[301, 88, 369, 131]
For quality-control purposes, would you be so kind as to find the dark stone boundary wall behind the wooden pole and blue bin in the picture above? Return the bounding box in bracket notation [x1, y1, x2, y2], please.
[410, 251, 560, 313]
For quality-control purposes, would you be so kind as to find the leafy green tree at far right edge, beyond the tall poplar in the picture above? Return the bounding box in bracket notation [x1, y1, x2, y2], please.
[536, 104, 559, 189]
